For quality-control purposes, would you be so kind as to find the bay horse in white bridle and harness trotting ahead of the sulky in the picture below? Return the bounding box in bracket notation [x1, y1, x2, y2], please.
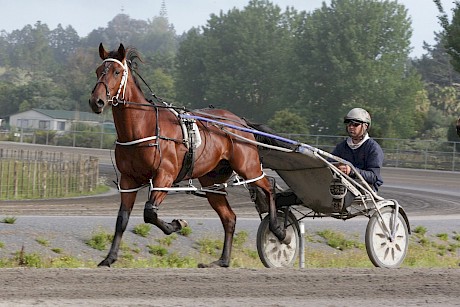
[89, 43, 290, 267]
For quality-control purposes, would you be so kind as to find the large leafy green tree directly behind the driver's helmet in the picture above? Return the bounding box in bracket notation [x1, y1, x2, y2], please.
[296, 0, 423, 137]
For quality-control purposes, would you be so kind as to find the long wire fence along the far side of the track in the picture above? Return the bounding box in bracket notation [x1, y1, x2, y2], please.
[0, 130, 460, 171]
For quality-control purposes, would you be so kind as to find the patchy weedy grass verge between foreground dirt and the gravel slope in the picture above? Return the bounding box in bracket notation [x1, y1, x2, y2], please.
[0, 226, 460, 268]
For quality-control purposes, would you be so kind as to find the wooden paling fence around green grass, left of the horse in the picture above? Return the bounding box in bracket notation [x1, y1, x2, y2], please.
[0, 148, 99, 200]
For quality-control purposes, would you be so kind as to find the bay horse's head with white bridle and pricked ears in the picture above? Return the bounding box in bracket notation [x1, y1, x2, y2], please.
[89, 43, 129, 114]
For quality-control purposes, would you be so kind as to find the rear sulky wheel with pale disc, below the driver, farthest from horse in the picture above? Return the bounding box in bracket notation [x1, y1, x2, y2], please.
[365, 207, 409, 268]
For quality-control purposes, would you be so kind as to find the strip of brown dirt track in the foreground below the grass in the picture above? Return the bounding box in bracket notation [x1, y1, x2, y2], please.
[0, 269, 460, 306]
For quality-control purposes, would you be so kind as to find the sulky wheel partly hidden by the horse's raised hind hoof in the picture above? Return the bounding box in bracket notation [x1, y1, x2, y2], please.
[257, 211, 300, 268]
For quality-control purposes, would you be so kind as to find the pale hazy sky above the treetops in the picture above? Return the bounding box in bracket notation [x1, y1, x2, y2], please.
[0, 0, 454, 57]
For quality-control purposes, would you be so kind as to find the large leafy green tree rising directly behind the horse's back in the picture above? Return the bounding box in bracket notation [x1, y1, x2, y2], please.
[173, 0, 296, 121]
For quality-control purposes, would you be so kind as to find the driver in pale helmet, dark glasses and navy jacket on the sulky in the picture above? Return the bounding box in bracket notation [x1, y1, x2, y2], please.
[332, 108, 383, 191]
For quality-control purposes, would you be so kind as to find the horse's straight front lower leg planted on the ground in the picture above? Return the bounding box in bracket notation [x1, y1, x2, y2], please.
[98, 192, 137, 267]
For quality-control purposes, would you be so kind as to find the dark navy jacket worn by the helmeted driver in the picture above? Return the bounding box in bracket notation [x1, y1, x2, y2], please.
[332, 138, 383, 191]
